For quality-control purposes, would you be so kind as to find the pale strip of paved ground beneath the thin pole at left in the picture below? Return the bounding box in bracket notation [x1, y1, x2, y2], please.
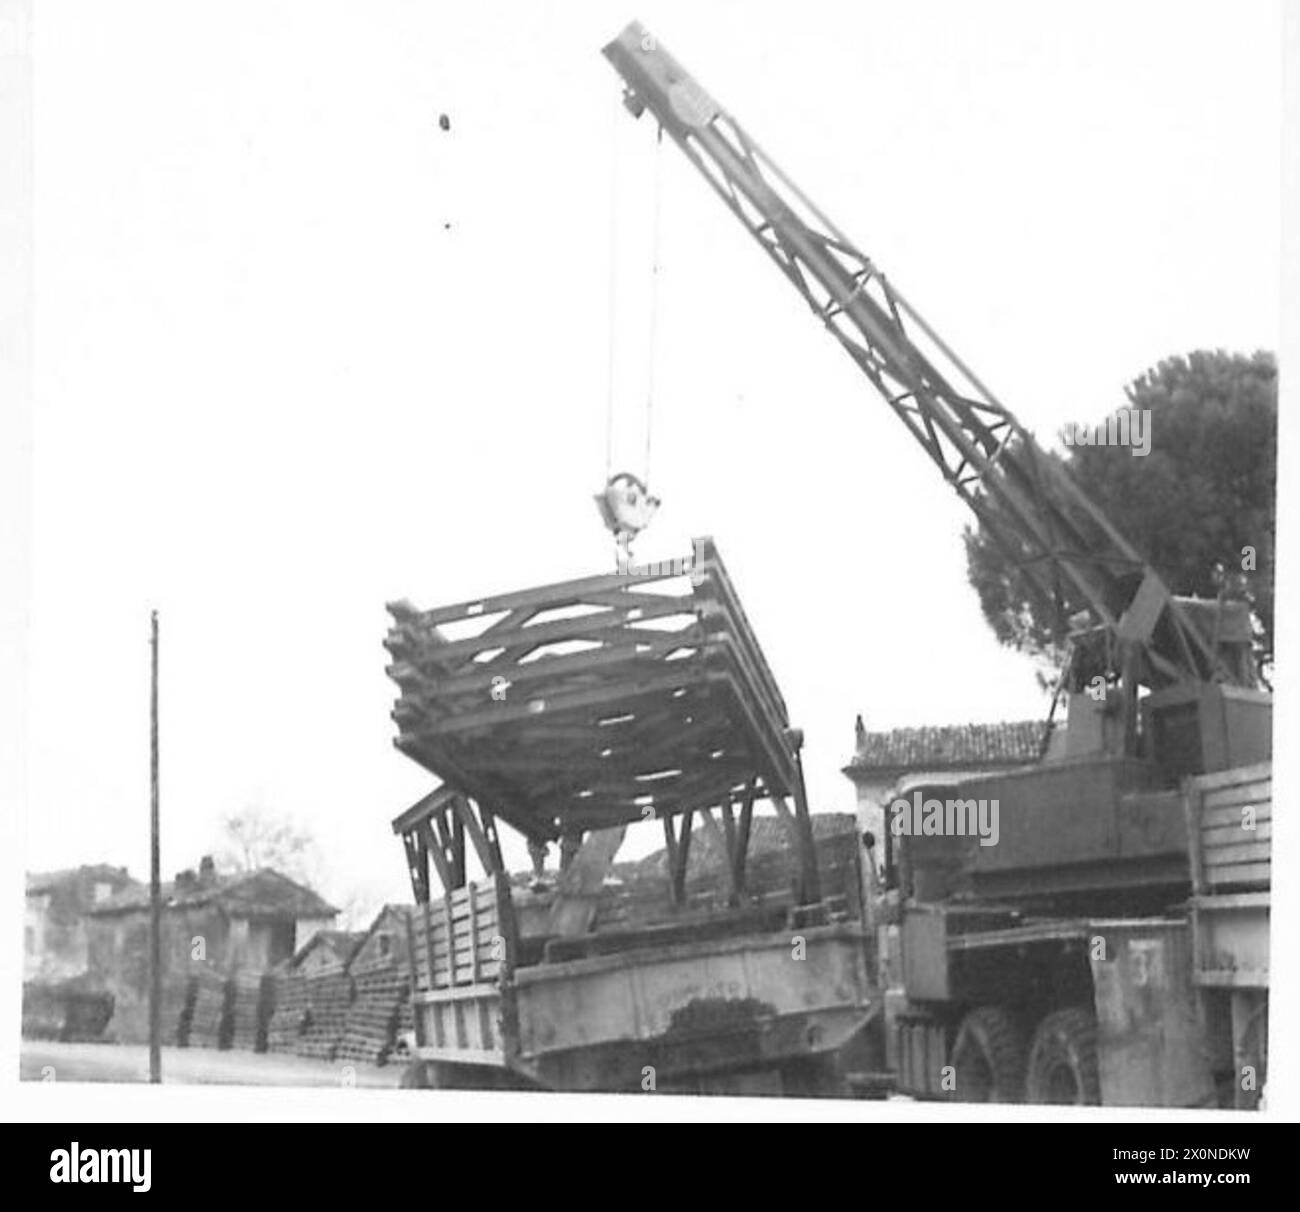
[20, 1039, 404, 1088]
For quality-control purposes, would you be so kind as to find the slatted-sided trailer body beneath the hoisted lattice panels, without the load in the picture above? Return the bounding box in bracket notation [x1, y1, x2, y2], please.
[410, 884, 879, 1094]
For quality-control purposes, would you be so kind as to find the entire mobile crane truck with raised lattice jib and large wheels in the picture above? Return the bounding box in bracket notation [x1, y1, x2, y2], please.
[605, 23, 1273, 1107]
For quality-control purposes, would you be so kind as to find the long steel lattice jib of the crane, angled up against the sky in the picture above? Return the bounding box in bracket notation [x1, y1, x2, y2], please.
[605, 22, 1239, 685]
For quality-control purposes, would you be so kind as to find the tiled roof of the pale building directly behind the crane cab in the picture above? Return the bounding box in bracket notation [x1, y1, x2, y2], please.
[845, 718, 1048, 776]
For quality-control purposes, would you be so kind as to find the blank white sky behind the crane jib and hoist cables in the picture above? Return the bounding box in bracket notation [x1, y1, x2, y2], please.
[26, 0, 1281, 920]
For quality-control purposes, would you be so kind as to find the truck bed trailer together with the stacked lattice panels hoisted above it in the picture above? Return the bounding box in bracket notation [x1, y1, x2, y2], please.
[386, 538, 881, 1094]
